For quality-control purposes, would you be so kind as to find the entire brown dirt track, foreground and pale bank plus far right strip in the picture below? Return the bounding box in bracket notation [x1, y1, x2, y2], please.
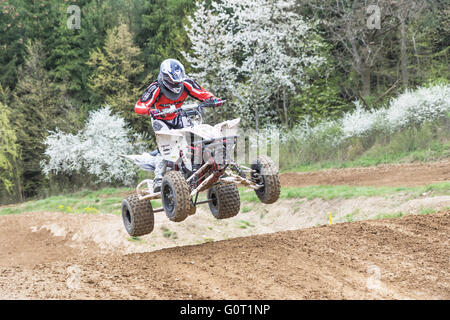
[0, 161, 450, 299]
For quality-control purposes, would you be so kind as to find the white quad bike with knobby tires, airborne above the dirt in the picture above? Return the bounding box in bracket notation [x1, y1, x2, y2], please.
[122, 103, 280, 236]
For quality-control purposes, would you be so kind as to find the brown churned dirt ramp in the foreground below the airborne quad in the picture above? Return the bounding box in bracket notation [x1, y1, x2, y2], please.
[0, 211, 450, 299]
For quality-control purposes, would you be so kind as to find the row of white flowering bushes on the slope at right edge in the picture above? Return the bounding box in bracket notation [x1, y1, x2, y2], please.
[280, 85, 450, 166]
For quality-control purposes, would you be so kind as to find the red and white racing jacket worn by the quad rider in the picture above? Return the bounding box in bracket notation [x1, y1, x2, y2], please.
[134, 79, 214, 120]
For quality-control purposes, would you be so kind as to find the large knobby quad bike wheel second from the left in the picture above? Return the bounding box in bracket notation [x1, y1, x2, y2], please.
[161, 171, 195, 222]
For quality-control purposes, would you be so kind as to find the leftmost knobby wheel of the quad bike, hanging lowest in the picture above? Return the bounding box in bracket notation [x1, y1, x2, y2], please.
[122, 194, 155, 237]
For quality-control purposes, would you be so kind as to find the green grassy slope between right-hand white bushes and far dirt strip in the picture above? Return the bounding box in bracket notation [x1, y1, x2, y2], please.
[280, 117, 450, 172]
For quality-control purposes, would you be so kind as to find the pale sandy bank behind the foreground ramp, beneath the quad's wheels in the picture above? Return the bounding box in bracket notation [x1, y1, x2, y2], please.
[0, 194, 450, 265]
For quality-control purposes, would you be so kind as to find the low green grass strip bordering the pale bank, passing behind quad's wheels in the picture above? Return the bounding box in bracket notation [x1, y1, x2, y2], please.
[0, 182, 450, 215]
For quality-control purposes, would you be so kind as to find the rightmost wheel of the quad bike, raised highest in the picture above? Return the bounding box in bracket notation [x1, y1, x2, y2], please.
[251, 155, 281, 204]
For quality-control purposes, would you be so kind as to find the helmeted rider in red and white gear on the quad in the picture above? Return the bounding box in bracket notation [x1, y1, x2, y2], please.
[134, 59, 222, 192]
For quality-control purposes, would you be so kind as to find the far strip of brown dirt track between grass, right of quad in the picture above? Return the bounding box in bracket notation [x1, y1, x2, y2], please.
[280, 160, 450, 187]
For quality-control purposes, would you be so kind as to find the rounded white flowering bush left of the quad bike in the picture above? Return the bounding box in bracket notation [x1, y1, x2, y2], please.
[41, 107, 143, 185]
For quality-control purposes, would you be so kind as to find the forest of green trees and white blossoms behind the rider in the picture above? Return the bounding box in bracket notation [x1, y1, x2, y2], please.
[0, 0, 450, 204]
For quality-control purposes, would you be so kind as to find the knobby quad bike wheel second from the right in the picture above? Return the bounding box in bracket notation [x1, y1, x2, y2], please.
[207, 183, 241, 219]
